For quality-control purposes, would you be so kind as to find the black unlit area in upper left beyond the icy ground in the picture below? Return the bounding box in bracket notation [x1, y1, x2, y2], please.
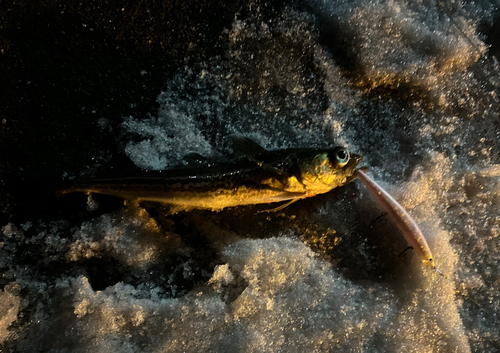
[0, 1, 240, 224]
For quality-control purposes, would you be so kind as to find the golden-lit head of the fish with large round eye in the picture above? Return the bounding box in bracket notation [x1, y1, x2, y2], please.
[300, 147, 363, 193]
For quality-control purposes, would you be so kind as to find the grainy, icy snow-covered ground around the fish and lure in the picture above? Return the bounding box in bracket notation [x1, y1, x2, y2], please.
[0, 0, 500, 352]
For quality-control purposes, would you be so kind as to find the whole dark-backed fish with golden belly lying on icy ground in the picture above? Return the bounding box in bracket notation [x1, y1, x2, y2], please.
[60, 136, 363, 213]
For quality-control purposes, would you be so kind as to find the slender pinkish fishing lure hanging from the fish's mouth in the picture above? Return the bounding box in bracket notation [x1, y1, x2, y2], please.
[356, 169, 434, 268]
